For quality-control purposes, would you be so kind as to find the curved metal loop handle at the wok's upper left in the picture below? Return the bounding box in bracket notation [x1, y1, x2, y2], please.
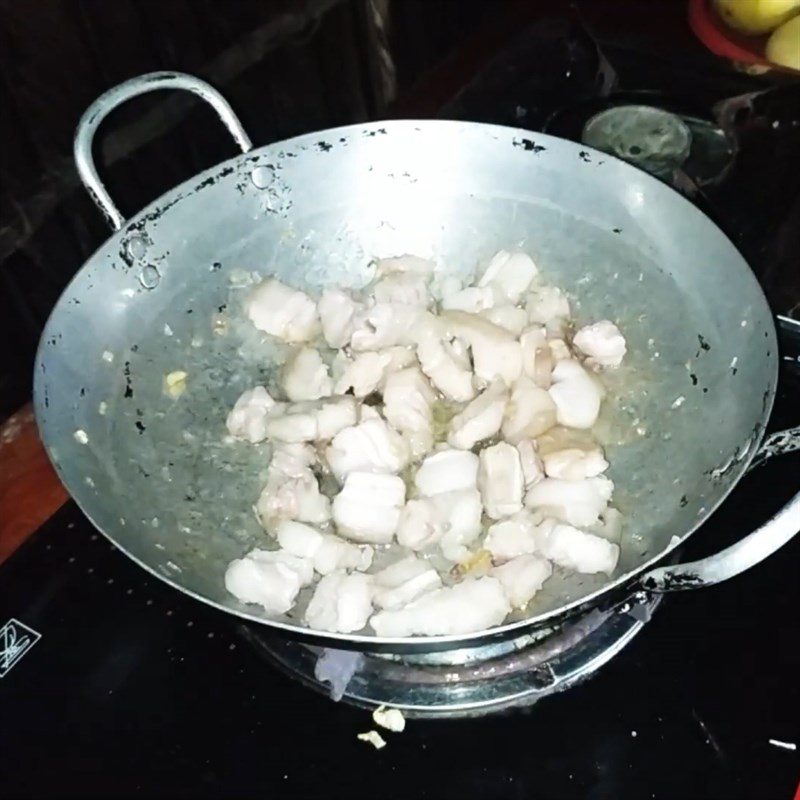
[73, 72, 253, 231]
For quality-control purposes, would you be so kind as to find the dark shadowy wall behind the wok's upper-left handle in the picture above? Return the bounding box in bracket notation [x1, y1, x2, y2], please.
[0, 0, 500, 412]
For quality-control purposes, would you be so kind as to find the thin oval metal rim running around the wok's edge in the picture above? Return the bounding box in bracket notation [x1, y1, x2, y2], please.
[33, 119, 779, 653]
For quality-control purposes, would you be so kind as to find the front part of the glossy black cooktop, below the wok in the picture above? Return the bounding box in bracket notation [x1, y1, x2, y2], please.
[0, 416, 800, 800]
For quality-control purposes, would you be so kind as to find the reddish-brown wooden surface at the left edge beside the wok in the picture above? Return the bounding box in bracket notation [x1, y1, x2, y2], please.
[0, 403, 67, 563]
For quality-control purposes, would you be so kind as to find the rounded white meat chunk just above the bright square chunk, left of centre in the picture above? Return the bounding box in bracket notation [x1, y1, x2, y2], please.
[325, 419, 409, 481]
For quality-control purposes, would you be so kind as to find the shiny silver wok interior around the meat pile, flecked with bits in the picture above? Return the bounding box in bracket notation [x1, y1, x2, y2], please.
[35, 121, 777, 649]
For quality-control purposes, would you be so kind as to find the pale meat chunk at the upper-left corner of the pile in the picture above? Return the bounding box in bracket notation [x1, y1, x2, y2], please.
[244, 278, 320, 342]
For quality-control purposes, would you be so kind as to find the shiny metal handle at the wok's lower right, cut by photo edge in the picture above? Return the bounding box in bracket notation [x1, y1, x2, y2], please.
[642, 492, 800, 593]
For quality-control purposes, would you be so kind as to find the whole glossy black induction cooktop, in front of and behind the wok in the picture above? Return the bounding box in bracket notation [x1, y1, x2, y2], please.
[0, 7, 800, 800]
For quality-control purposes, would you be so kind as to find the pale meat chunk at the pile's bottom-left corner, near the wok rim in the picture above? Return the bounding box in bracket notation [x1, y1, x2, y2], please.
[225, 550, 313, 614]
